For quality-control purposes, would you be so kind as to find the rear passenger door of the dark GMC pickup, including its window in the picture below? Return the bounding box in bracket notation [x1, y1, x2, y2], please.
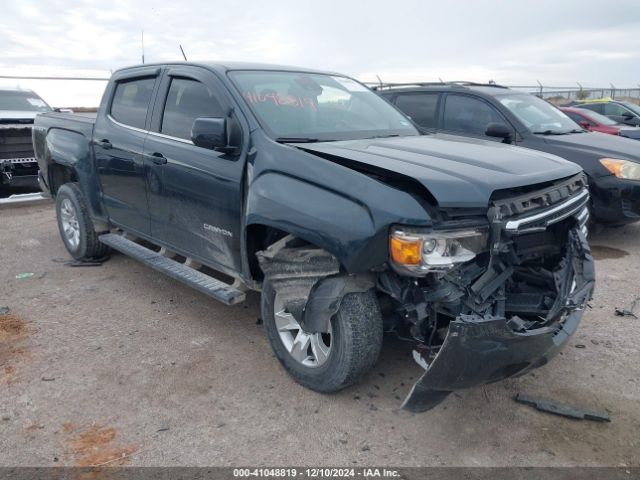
[93, 67, 160, 235]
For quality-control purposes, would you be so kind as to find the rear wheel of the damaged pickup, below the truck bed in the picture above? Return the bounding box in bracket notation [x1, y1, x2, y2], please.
[56, 183, 109, 261]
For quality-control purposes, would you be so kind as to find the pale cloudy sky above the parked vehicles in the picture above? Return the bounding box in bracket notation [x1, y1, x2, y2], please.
[0, 0, 640, 106]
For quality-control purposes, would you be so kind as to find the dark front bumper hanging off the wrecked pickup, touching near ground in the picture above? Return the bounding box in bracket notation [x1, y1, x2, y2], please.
[402, 228, 595, 412]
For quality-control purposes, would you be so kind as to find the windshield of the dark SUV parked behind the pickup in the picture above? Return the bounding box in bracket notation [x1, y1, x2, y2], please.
[498, 94, 582, 135]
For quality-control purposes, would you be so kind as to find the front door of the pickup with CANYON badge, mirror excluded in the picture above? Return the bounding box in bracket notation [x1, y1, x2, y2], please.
[145, 66, 243, 271]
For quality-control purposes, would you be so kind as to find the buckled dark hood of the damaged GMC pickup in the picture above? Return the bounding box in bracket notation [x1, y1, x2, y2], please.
[298, 134, 581, 208]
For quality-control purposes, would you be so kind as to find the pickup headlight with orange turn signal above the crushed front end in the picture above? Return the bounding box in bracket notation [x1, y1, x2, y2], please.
[389, 227, 488, 275]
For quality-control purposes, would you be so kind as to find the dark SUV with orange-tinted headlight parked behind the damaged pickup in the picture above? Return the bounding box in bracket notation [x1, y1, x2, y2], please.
[374, 82, 640, 225]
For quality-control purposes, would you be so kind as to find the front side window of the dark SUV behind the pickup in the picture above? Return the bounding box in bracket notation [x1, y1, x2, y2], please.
[444, 95, 506, 135]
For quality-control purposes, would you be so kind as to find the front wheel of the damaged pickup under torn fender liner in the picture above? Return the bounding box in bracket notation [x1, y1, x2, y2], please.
[261, 279, 383, 393]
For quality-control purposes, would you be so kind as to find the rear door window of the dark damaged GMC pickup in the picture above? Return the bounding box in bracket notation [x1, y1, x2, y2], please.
[110, 77, 156, 128]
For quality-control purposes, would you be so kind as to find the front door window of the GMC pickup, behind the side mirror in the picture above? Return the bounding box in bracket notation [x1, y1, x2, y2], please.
[160, 78, 224, 140]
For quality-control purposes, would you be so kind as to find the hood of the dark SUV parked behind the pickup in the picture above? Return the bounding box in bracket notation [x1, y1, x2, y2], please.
[544, 128, 640, 162]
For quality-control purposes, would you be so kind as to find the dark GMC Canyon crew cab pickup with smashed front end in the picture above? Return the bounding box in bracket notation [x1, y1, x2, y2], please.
[34, 63, 594, 411]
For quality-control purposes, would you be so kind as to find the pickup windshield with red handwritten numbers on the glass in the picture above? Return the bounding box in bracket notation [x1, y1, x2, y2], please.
[230, 71, 419, 142]
